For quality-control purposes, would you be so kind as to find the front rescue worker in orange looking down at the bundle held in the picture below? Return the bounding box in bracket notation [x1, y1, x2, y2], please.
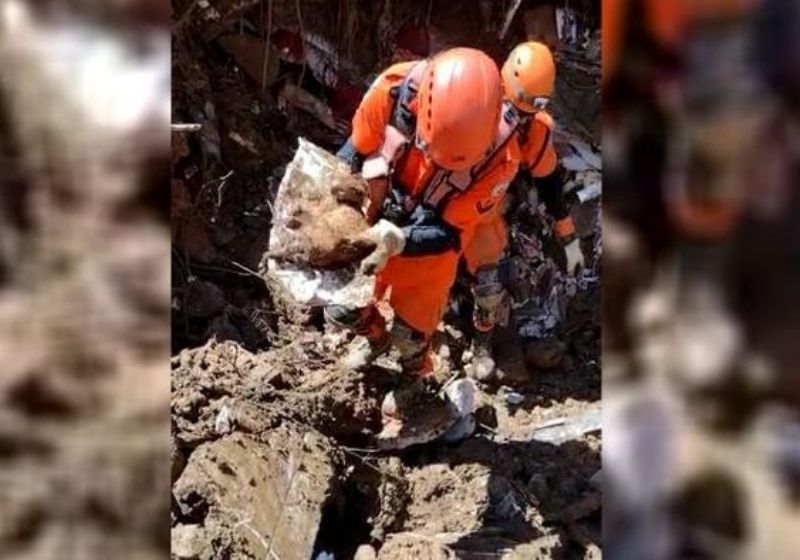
[326, 48, 519, 437]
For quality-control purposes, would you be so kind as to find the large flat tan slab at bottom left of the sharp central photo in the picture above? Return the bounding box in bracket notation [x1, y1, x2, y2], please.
[173, 427, 334, 560]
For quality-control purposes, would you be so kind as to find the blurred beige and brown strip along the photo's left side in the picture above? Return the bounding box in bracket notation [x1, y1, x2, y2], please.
[0, 0, 170, 560]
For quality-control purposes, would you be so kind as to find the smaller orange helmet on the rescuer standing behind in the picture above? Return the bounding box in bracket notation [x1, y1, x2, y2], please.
[503, 41, 556, 113]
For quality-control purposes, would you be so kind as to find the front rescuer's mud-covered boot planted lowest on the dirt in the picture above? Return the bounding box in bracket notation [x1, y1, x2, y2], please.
[377, 376, 461, 450]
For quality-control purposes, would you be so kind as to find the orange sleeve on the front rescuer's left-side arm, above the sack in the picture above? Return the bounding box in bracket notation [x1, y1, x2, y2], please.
[351, 62, 414, 155]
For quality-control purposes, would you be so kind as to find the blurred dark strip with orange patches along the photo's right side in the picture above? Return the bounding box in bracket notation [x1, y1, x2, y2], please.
[602, 0, 800, 560]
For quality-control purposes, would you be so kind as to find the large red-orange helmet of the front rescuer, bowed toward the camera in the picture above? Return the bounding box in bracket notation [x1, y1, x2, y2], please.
[417, 48, 502, 171]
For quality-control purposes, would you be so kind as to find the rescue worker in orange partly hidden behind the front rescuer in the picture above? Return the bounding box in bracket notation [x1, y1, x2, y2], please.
[464, 41, 583, 380]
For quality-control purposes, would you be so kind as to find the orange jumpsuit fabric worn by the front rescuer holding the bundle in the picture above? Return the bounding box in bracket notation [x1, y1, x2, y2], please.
[351, 62, 521, 337]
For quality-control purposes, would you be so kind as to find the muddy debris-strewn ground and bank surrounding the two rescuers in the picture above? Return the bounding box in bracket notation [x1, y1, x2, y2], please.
[171, 1, 601, 560]
